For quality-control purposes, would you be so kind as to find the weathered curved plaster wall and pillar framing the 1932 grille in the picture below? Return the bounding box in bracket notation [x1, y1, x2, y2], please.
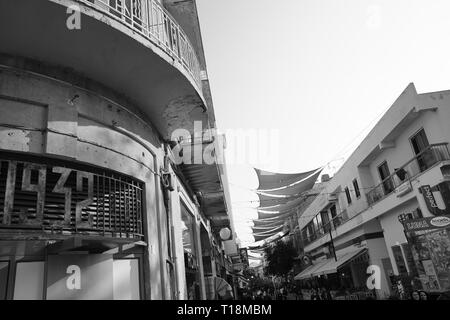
[0, 68, 166, 299]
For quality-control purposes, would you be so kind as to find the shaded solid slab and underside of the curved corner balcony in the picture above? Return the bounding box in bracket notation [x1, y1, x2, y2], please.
[0, 0, 207, 138]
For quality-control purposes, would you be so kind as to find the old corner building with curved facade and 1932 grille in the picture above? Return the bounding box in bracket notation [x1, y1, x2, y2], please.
[0, 0, 237, 299]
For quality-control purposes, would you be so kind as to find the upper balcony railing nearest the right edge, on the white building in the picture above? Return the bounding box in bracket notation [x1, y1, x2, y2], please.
[366, 143, 450, 205]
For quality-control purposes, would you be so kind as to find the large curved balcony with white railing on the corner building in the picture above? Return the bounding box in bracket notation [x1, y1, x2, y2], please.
[0, 0, 207, 138]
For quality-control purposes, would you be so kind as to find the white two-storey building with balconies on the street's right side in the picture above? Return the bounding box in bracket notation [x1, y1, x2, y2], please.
[295, 84, 450, 299]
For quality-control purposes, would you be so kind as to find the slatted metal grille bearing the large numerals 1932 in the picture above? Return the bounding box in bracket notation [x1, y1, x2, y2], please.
[0, 155, 143, 234]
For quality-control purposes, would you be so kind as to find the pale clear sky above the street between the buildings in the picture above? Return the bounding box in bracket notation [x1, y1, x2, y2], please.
[197, 0, 450, 245]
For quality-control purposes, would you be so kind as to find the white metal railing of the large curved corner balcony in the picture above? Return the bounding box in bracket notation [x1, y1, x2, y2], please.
[76, 0, 202, 90]
